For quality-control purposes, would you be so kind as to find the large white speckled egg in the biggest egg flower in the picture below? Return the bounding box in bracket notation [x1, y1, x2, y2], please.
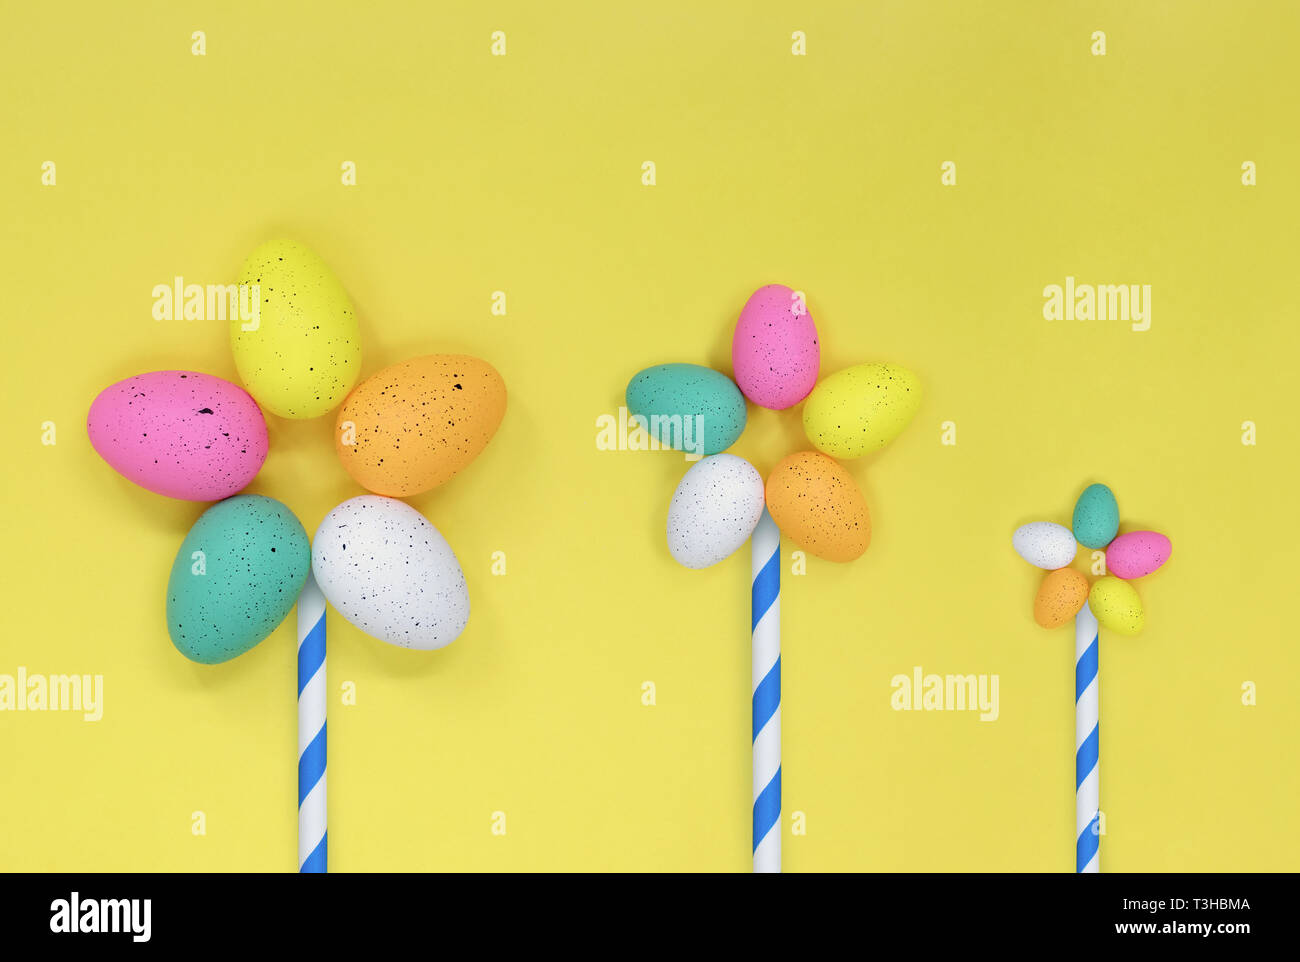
[312, 494, 469, 651]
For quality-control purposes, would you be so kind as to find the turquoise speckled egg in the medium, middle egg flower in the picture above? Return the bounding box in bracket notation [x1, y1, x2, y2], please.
[628, 364, 745, 456]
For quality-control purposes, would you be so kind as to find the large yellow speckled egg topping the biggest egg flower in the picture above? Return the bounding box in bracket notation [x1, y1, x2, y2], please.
[230, 241, 361, 419]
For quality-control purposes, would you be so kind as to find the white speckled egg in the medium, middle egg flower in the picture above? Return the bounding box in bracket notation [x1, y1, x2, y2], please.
[668, 454, 763, 568]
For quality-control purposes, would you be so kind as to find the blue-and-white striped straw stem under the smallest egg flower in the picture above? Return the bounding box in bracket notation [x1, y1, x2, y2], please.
[1074, 602, 1101, 872]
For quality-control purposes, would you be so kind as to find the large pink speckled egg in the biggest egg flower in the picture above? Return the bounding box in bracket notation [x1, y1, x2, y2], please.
[86, 371, 267, 501]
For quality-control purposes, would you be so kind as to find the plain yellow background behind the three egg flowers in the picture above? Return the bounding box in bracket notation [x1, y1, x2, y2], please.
[0, 0, 1300, 871]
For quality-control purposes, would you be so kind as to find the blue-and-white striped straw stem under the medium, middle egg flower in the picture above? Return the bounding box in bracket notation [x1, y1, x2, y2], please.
[750, 508, 781, 872]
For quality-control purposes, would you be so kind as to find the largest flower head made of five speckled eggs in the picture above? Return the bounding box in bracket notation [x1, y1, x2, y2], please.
[87, 241, 506, 664]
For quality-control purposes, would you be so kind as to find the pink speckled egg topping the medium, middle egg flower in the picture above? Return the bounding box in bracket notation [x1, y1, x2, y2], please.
[732, 283, 822, 411]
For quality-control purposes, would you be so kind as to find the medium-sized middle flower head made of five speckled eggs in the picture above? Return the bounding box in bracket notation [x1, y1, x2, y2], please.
[627, 283, 920, 568]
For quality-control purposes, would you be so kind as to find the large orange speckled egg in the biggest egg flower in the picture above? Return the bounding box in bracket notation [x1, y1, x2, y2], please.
[334, 354, 506, 498]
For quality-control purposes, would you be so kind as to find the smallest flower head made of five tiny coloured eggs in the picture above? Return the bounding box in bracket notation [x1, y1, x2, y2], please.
[1011, 484, 1173, 636]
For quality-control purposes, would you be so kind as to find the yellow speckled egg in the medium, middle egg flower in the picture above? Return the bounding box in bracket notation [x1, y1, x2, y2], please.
[803, 364, 920, 458]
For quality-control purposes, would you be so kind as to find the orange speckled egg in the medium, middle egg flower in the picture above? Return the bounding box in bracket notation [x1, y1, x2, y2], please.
[767, 451, 871, 562]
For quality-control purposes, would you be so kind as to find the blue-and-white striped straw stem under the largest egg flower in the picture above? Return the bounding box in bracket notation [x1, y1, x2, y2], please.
[298, 572, 326, 872]
